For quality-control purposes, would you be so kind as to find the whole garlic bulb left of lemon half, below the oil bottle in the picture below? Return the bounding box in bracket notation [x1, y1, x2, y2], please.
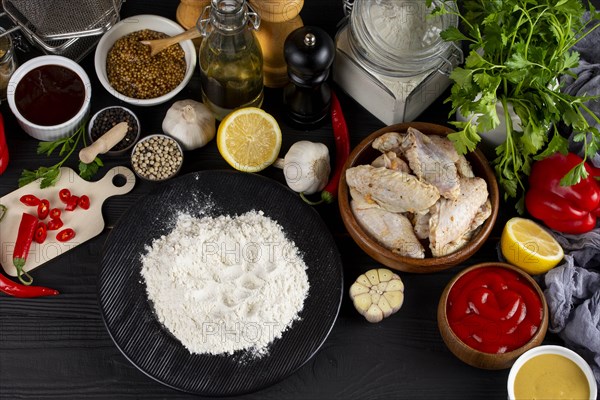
[162, 100, 216, 150]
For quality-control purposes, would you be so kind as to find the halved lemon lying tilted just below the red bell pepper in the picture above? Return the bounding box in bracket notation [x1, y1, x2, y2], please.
[500, 217, 564, 275]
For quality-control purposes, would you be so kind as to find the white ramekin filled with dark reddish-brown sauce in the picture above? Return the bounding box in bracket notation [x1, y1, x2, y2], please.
[7, 55, 92, 141]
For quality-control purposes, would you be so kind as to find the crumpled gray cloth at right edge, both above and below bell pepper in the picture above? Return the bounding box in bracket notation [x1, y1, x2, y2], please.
[543, 14, 600, 385]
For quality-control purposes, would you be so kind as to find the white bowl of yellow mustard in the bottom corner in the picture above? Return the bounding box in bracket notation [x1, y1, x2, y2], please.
[508, 345, 598, 400]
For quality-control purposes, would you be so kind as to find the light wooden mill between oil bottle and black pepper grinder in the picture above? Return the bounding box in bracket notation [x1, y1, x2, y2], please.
[248, 0, 304, 88]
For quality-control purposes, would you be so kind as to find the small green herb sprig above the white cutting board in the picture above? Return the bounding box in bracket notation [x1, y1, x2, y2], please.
[19, 123, 104, 189]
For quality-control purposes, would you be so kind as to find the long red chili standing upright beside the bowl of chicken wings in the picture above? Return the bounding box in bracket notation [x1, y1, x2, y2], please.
[300, 92, 350, 205]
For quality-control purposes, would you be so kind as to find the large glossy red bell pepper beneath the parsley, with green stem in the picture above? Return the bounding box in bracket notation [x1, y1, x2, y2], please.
[525, 153, 600, 234]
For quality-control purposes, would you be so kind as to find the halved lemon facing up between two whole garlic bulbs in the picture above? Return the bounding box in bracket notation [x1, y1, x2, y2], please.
[217, 107, 281, 172]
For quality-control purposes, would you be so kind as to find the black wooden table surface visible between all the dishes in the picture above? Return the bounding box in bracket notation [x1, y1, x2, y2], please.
[0, 0, 596, 400]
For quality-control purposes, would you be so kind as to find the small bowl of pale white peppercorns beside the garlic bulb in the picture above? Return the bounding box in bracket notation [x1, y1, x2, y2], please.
[131, 134, 183, 182]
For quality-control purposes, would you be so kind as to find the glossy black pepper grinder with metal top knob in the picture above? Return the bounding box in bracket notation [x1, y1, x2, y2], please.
[283, 26, 335, 128]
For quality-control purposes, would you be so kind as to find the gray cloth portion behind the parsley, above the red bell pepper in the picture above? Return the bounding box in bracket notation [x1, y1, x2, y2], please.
[562, 15, 600, 167]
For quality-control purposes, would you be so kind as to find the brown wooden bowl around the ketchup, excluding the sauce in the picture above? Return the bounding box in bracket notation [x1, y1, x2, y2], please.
[437, 262, 549, 370]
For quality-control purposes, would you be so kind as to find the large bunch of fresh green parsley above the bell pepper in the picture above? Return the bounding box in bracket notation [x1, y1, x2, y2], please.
[427, 0, 600, 210]
